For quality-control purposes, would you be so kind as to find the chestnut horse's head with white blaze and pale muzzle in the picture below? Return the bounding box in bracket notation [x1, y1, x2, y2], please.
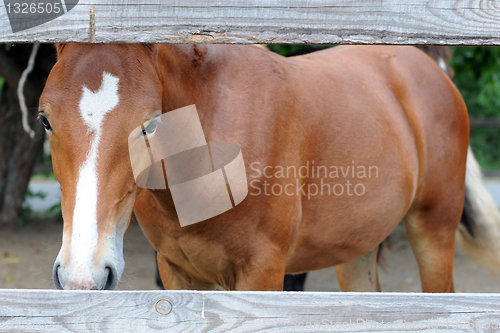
[39, 44, 162, 290]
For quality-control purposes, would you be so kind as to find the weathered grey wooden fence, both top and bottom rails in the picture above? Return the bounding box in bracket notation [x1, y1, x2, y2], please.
[0, 0, 500, 333]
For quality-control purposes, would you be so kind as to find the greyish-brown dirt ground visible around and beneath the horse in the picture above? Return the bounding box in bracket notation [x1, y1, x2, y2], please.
[0, 222, 500, 292]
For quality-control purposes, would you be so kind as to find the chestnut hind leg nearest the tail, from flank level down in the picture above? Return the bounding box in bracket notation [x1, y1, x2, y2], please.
[404, 207, 460, 292]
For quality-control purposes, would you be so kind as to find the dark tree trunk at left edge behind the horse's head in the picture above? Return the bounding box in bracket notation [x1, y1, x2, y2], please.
[0, 45, 54, 225]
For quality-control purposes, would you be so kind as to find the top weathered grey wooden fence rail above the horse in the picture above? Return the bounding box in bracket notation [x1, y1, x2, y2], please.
[0, 0, 500, 45]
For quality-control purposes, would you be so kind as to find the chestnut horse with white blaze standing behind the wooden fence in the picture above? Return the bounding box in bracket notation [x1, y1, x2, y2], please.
[40, 44, 469, 292]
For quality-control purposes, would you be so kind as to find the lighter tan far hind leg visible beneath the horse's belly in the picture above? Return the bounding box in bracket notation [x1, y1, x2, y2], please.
[335, 246, 380, 291]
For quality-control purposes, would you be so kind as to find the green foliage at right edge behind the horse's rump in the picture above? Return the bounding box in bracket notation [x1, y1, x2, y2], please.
[450, 46, 500, 169]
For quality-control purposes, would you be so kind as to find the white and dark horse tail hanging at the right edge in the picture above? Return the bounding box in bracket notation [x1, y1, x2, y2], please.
[456, 147, 500, 271]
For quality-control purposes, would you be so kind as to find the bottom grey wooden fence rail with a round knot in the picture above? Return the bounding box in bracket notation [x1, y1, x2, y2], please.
[0, 290, 500, 333]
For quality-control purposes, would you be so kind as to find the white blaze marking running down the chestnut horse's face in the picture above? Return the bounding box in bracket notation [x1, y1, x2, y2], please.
[68, 72, 119, 284]
